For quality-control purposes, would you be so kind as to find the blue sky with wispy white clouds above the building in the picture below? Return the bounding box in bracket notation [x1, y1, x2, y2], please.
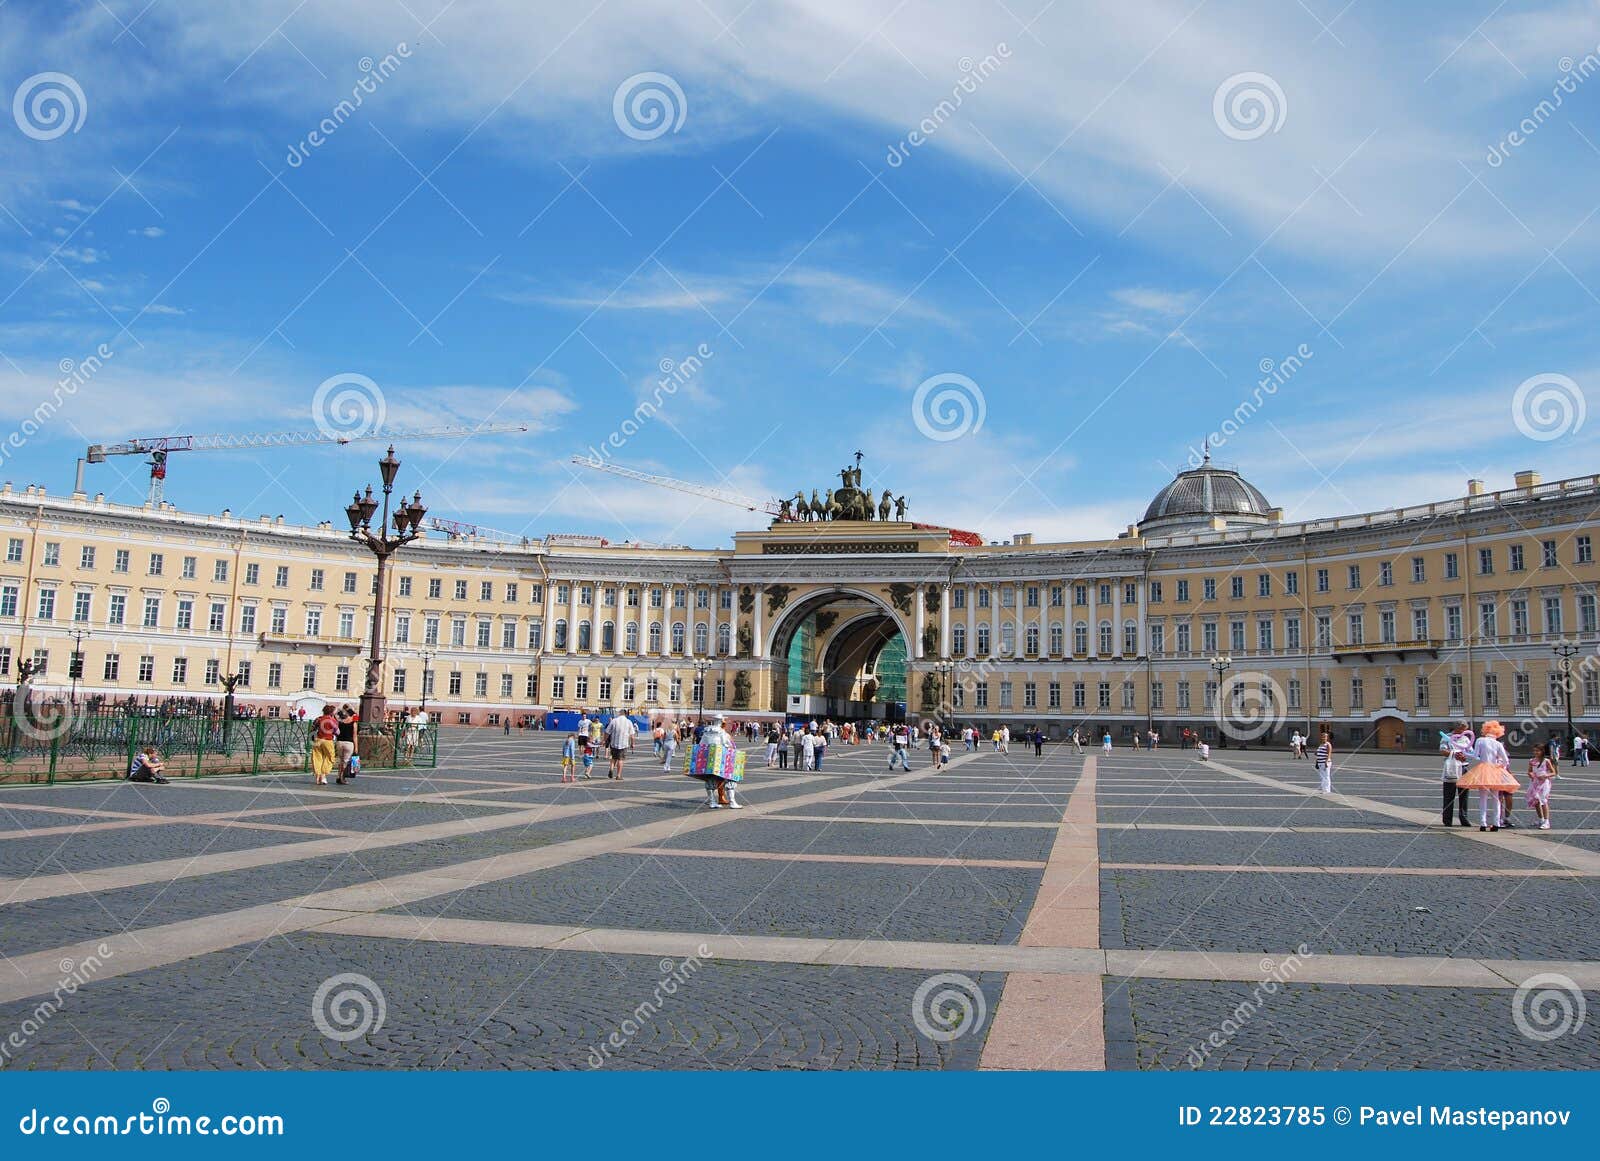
[0, 0, 1600, 544]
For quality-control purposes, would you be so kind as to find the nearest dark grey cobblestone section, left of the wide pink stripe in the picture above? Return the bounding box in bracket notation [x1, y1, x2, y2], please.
[0, 934, 998, 1070]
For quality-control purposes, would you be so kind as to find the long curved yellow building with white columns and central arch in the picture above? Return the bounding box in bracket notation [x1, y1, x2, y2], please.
[0, 462, 1600, 750]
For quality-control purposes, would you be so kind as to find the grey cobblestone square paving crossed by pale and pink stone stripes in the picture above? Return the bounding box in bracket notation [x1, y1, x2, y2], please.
[0, 731, 1600, 1070]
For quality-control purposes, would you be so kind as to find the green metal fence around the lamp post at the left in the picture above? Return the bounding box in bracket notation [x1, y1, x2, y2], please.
[0, 710, 438, 785]
